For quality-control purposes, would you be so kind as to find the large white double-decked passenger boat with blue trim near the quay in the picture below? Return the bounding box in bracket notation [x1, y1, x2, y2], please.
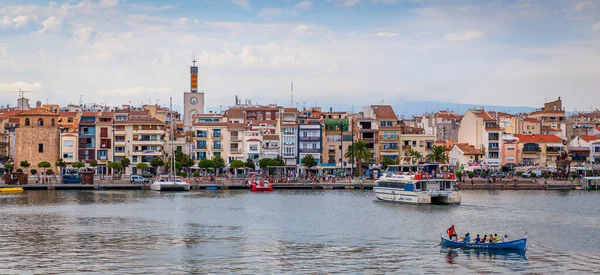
[373, 163, 461, 205]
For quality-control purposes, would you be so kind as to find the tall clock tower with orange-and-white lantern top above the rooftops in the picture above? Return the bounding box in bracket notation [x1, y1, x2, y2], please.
[183, 59, 204, 130]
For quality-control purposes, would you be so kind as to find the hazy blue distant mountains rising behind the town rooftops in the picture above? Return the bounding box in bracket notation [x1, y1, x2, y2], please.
[200, 101, 536, 117]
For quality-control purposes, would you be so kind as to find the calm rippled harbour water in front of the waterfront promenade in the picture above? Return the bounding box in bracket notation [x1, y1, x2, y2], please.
[0, 190, 600, 274]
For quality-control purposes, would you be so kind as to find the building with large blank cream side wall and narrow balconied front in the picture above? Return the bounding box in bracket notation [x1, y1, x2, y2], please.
[458, 109, 504, 168]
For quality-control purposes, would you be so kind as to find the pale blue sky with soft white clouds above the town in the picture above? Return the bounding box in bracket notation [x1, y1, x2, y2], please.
[0, 0, 600, 113]
